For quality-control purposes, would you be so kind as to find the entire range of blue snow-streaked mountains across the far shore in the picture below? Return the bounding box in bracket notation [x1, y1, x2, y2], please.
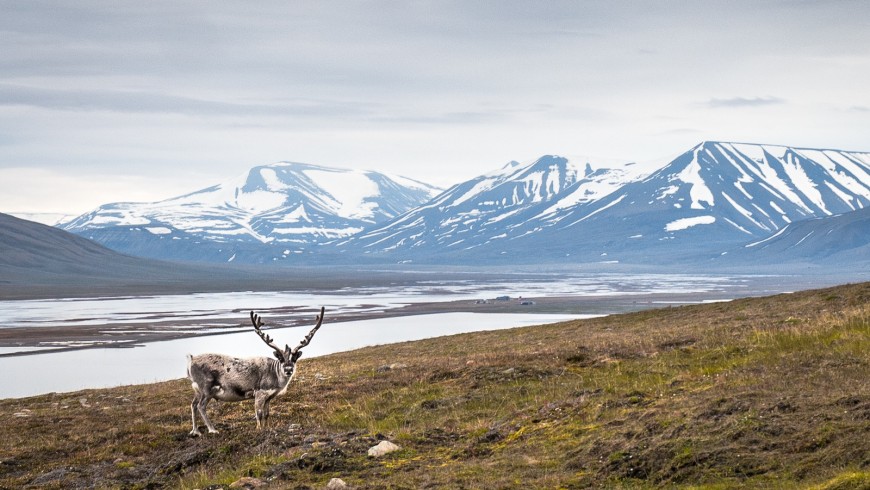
[62, 142, 870, 265]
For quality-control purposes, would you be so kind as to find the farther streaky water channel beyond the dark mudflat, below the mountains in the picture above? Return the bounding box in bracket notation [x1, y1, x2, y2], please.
[0, 274, 755, 328]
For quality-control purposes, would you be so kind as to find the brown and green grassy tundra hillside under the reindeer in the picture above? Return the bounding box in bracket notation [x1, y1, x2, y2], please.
[0, 283, 870, 490]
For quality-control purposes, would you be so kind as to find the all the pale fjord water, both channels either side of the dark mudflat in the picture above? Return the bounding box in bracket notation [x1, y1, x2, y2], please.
[0, 274, 796, 398]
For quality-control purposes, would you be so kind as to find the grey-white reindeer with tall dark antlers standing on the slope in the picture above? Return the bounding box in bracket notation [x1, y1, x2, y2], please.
[187, 308, 324, 436]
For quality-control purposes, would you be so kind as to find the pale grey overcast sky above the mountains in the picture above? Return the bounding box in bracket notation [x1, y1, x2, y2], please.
[0, 0, 870, 218]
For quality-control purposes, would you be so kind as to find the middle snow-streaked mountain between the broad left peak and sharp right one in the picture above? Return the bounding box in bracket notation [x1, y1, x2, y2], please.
[337, 155, 664, 260]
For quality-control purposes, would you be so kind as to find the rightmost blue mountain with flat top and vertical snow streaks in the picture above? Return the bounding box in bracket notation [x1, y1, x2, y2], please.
[532, 142, 870, 260]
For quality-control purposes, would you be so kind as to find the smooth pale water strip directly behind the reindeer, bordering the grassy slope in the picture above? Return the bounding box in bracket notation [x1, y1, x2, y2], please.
[0, 313, 593, 398]
